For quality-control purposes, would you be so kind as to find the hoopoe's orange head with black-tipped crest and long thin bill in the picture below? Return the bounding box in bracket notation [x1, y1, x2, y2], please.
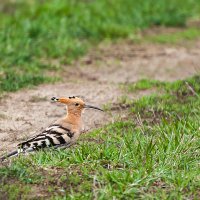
[51, 96, 103, 113]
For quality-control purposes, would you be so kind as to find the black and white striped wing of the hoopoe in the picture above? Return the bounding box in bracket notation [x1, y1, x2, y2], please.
[18, 124, 74, 152]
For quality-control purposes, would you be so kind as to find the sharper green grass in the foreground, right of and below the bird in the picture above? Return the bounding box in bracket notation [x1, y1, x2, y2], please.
[0, 76, 200, 199]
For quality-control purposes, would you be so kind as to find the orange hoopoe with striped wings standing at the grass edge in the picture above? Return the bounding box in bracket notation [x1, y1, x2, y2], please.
[1, 96, 103, 160]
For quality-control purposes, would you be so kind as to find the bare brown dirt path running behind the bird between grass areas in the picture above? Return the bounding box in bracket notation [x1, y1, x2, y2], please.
[0, 32, 200, 154]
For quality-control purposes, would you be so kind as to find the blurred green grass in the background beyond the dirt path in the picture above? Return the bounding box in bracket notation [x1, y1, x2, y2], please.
[0, 0, 200, 92]
